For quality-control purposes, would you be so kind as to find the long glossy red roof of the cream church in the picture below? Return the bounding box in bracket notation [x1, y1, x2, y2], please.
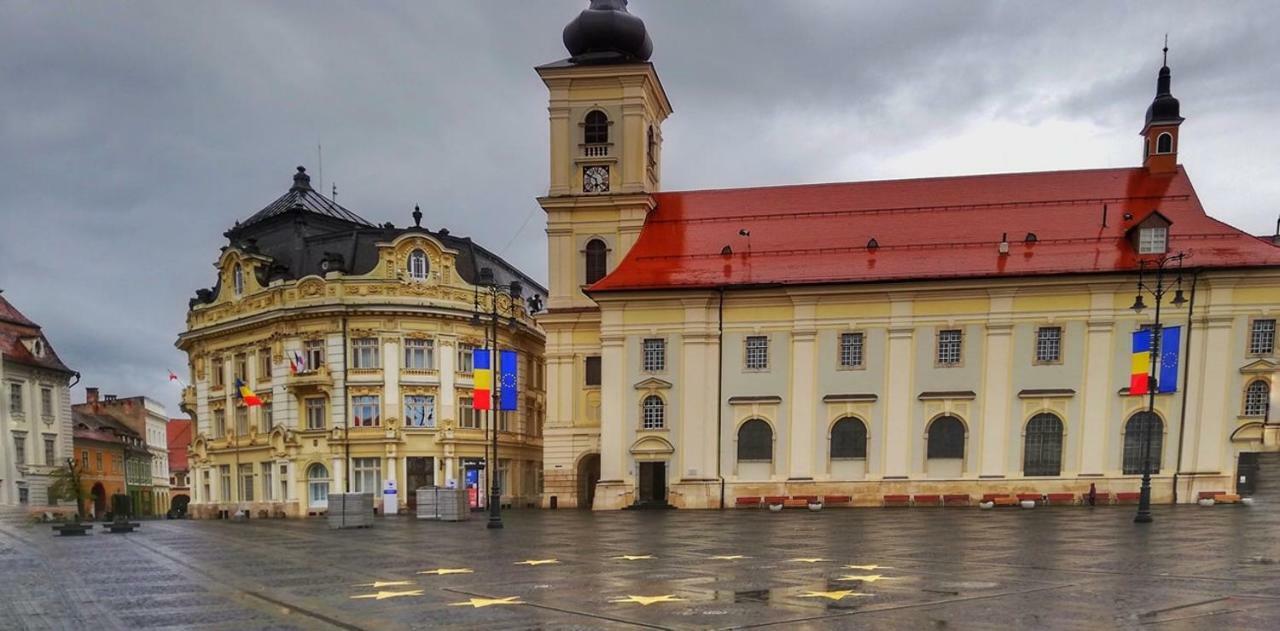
[589, 166, 1280, 293]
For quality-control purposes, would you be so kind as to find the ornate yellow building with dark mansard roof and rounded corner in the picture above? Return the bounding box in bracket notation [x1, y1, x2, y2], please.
[177, 166, 545, 517]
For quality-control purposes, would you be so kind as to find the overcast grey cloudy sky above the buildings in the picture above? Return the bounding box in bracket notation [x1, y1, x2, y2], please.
[0, 0, 1280, 416]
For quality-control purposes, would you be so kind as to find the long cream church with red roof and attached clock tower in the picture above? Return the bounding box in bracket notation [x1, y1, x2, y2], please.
[536, 0, 1280, 509]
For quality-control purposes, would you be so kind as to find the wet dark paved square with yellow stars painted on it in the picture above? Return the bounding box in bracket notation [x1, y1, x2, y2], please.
[0, 504, 1280, 630]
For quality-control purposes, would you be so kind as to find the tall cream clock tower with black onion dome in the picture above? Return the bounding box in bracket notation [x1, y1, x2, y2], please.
[536, 0, 671, 507]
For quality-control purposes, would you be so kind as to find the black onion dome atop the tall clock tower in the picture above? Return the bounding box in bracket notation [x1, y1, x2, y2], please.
[564, 0, 653, 63]
